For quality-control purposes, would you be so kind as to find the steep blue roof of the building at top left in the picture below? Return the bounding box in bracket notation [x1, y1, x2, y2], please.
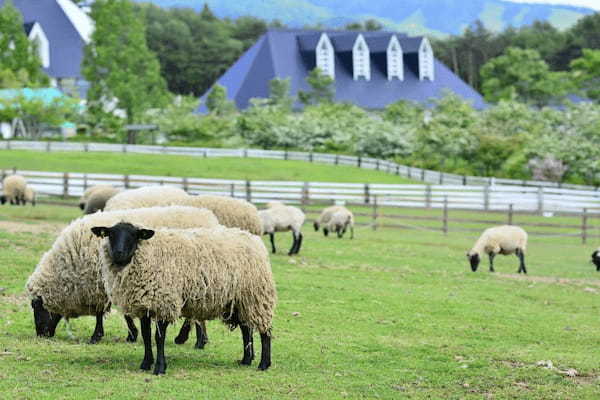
[0, 0, 85, 78]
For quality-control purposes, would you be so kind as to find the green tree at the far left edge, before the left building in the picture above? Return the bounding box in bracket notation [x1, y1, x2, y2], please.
[0, 0, 48, 88]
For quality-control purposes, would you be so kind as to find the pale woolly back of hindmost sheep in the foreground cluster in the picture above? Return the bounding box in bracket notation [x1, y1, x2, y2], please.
[104, 186, 189, 211]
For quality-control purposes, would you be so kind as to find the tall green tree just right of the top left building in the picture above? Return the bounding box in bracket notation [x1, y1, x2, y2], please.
[83, 0, 167, 123]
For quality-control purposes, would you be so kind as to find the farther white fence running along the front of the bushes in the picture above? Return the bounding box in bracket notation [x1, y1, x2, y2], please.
[0, 140, 598, 191]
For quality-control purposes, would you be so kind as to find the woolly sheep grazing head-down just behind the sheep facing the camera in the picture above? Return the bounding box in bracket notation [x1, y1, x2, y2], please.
[25, 206, 218, 343]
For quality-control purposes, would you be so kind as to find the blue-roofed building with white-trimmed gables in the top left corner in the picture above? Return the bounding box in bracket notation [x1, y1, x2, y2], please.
[0, 0, 94, 97]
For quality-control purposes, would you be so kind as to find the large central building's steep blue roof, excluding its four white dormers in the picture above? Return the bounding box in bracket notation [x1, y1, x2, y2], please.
[197, 30, 486, 113]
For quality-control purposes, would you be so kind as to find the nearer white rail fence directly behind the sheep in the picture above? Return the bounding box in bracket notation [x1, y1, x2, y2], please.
[0, 169, 600, 214]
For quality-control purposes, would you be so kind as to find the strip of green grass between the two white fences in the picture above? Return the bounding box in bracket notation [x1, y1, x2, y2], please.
[0, 150, 414, 183]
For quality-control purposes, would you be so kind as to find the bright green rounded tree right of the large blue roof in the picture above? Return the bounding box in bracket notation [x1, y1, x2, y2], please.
[481, 47, 571, 106]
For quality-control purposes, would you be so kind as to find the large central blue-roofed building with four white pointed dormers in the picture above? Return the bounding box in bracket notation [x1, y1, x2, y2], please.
[197, 30, 486, 113]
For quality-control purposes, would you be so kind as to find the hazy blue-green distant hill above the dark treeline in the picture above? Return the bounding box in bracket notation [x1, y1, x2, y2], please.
[137, 0, 594, 35]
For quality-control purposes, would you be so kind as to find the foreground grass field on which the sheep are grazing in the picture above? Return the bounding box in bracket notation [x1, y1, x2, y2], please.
[0, 206, 600, 399]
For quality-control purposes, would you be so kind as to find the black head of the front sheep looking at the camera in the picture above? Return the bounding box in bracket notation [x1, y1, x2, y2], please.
[92, 222, 154, 268]
